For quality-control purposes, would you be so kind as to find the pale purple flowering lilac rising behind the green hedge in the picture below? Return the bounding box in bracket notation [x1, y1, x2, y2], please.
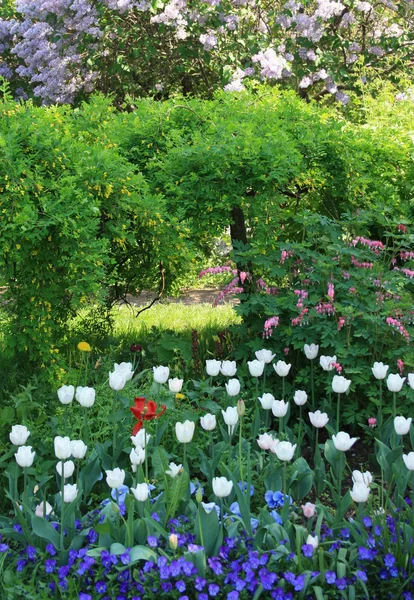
[0, 0, 414, 104]
